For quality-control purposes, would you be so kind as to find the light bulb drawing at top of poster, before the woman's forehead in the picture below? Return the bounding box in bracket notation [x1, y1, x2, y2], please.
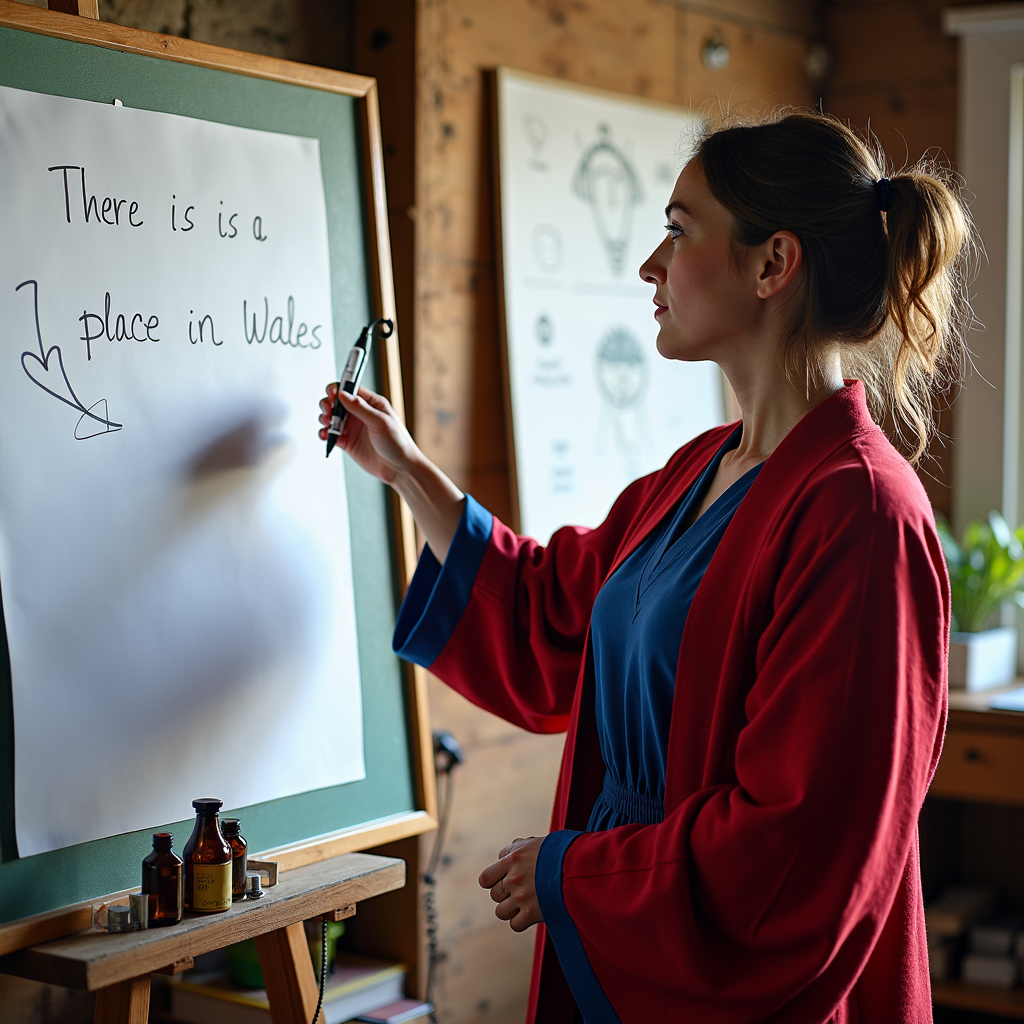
[572, 123, 643, 276]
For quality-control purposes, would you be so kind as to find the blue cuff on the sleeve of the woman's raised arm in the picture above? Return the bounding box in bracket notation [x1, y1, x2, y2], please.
[391, 495, 495, 669]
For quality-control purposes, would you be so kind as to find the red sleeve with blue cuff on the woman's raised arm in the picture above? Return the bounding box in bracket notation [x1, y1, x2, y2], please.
[394, 427, 732, 732]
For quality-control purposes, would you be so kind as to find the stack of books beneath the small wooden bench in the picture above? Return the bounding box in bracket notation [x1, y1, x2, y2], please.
[168, 954, 430, 1024]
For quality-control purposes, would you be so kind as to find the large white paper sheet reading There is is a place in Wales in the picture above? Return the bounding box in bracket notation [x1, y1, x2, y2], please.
[0, 88, 364, 856]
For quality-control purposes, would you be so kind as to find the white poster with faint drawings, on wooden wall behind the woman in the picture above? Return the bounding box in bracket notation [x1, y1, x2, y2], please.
[498, 69, 723, 541]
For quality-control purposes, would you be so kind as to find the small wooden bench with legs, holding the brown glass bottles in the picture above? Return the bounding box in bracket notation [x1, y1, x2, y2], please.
[0, 853, 406, 1024]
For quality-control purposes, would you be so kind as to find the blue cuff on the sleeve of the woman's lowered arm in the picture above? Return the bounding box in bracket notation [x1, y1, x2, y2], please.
[534, 828, 620, 1024]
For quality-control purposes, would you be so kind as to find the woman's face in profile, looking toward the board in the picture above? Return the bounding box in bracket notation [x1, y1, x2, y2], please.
[640, 160, 759, 361]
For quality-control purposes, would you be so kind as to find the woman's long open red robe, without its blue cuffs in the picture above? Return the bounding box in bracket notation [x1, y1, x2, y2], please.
[421, 383, 949, 1024]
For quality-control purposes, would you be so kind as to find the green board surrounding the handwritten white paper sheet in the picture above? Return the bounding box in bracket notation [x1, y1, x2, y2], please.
[0, 4, 430, 944]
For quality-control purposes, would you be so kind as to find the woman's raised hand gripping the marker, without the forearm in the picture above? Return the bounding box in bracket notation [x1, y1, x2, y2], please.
[319, 384, 422, 485]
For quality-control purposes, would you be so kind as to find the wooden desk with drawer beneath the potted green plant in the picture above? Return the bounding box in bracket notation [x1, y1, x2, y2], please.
[922, 680, 1024, 1020]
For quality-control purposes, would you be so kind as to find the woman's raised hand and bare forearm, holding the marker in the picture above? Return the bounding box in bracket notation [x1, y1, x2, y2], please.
[319, 384, 466, 562]
